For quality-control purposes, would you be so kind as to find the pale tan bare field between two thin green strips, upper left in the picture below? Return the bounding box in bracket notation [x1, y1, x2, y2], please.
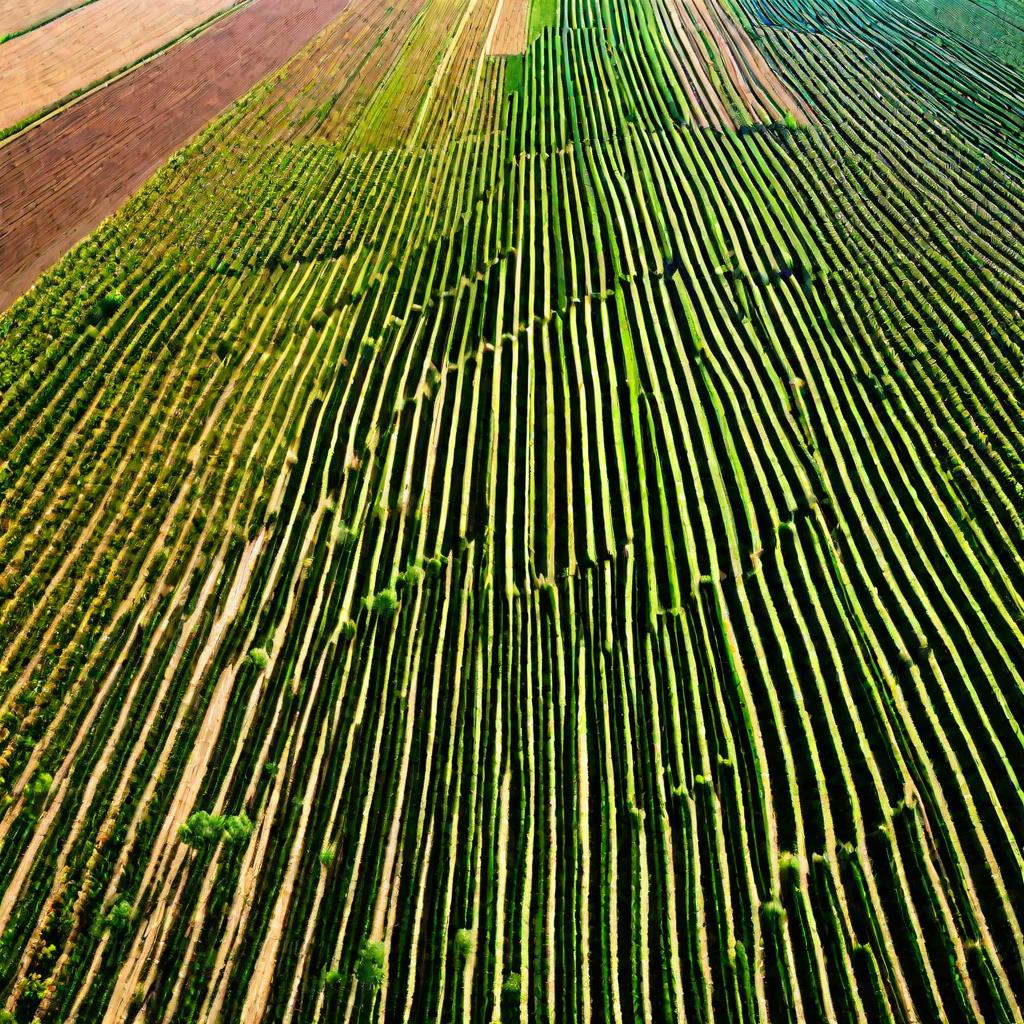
[0, 0, 245, 127]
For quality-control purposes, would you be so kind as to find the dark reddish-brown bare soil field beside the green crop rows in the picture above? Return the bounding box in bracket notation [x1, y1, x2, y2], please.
[0, 0, 347, 308]
